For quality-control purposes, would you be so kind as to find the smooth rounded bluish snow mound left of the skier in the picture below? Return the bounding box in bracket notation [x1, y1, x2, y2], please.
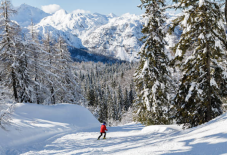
[0, 103, 100, 151]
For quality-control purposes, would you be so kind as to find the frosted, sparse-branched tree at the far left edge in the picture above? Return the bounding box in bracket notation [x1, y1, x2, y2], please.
[0, 0, 20, 101]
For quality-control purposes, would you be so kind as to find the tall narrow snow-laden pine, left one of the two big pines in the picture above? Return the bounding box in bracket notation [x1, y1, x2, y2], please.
[135, 0, 172, 125]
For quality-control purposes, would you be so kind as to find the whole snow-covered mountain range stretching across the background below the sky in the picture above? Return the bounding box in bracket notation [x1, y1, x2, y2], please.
[13, 4, 179, 61]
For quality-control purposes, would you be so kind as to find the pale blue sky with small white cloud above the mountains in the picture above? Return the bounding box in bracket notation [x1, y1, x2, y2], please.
[11, 0, 144, 16]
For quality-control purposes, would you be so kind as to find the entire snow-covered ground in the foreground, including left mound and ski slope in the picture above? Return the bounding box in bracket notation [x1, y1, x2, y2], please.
[0, 104, 227, 155]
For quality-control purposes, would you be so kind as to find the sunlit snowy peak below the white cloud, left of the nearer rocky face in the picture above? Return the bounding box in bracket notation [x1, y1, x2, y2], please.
[33, 10, 118, 48]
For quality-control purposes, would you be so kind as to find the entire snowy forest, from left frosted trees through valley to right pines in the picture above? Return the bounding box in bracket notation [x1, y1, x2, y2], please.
[0, 0, 227, 128]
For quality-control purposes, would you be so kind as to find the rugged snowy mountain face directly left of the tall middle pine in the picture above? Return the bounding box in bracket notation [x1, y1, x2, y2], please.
[83, 14, 144, 61]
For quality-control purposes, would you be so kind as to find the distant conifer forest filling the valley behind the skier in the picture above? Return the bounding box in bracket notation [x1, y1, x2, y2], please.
[77, 62, 136, 125]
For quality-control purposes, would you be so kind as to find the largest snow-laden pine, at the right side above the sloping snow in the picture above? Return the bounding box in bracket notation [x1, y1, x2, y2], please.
[171, 0, 227, 127]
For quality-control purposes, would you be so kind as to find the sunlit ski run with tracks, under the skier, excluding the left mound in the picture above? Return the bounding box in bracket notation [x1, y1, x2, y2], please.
[7, 121, 227, 155]
